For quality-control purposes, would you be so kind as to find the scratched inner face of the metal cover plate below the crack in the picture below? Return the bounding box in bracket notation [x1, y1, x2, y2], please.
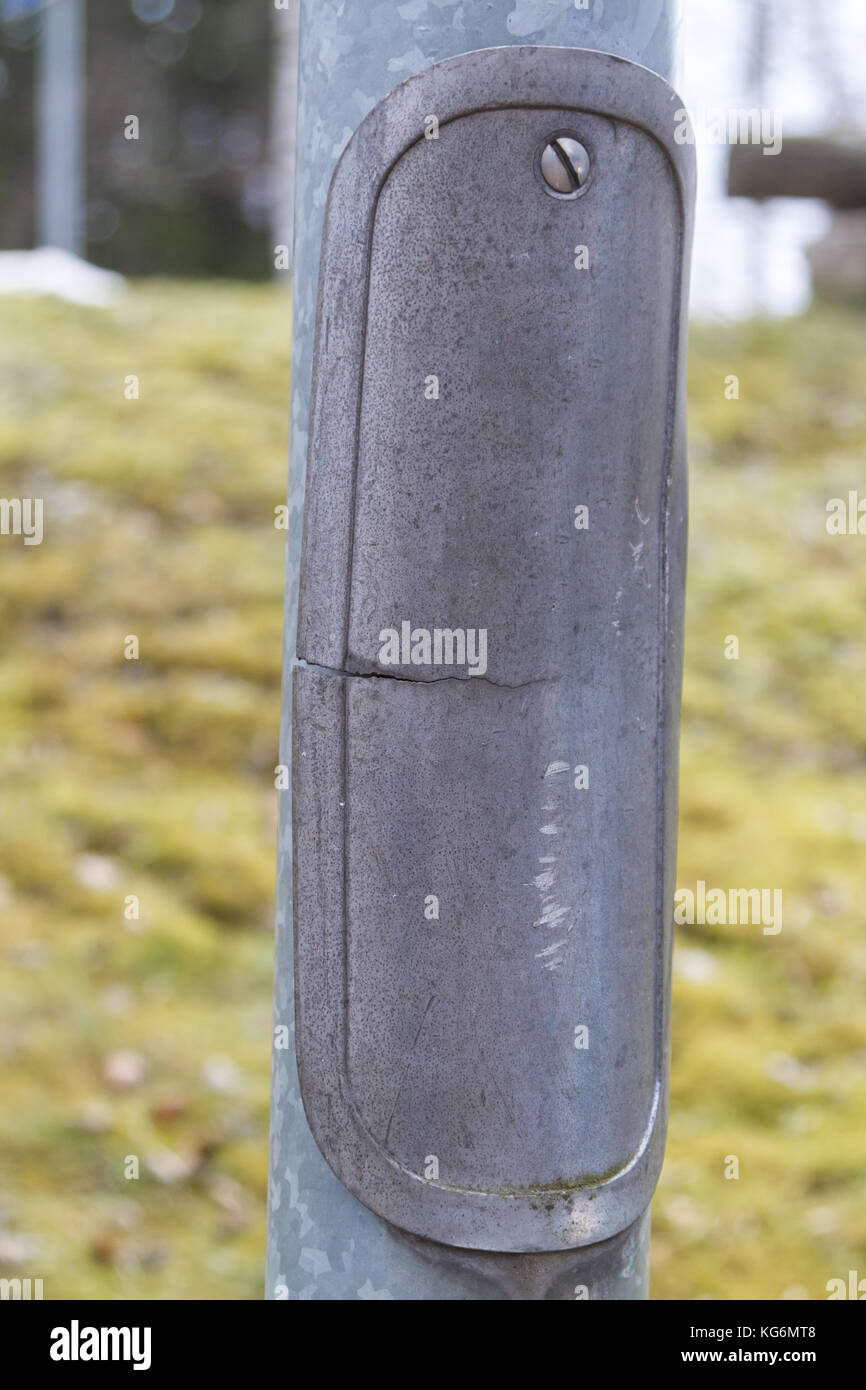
[345, 677, 657, 1191]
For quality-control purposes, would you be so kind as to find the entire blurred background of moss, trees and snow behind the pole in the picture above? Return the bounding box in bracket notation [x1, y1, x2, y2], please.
[0, 0, 866, 1300]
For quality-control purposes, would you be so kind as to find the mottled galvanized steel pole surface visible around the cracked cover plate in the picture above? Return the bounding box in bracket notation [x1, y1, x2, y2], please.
[265, 0, 678, 1300]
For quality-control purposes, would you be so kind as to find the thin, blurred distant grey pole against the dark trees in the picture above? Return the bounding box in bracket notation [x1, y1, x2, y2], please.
[36, 0, 85, 256]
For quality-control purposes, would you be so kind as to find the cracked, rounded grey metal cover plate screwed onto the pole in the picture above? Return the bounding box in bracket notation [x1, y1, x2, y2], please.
[293, 47, 694, 1251]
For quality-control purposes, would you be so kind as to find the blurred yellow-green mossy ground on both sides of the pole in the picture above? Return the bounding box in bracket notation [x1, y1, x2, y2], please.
[0, 284, 866, 1300]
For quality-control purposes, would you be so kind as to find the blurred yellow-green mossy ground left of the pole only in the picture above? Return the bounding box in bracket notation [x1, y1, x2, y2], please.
[0, 285, 289, 1298]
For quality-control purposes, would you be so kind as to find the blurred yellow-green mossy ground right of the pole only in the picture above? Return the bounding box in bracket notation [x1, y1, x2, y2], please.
[653, 311, 866, 1300]
